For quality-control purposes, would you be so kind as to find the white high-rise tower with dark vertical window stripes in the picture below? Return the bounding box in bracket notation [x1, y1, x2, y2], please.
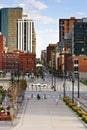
[17, 15, 36, 54]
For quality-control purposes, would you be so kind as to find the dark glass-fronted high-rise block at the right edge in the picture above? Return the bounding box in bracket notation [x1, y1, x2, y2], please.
[72, 18, 87, 56]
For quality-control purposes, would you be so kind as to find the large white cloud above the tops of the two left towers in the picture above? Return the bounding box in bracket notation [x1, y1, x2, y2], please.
[0, 0, 56, 24]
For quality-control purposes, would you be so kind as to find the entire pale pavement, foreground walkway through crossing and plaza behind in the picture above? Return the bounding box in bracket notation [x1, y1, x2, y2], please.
[0, 75, 87, 130]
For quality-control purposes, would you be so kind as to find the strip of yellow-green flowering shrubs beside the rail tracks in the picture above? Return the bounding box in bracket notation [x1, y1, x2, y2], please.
[63, 97, 87, 124]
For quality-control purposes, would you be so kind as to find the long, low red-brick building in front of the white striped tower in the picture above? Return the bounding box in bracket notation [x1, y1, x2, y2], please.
[2, 50, 36, 75]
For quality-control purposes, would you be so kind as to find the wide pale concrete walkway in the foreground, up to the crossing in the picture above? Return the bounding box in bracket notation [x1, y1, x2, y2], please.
[11, 97, 87, 130]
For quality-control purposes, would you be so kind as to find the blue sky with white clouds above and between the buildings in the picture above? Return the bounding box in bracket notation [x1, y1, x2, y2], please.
[0, 0, 87, 58]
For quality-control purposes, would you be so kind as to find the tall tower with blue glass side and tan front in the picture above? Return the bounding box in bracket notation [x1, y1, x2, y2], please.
[0, 7, 23, 52]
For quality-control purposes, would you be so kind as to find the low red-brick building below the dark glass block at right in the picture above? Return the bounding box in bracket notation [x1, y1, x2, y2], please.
[66, 55, 87, 79]
